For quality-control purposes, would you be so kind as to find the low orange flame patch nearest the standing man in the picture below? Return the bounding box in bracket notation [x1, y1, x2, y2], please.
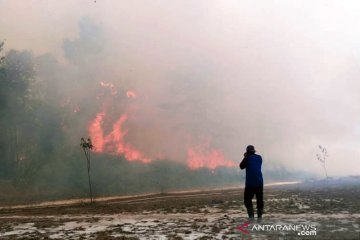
[187, 142, 236, 170]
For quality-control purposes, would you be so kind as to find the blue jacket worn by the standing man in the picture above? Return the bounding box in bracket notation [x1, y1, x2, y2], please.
[240, 153, 264, 187]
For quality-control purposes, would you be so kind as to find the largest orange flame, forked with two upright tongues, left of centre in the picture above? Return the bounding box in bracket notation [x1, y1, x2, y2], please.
[88, 112, 151, 163]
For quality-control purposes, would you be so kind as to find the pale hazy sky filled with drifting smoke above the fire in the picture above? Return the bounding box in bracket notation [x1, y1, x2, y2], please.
[0, 0, 360, 175]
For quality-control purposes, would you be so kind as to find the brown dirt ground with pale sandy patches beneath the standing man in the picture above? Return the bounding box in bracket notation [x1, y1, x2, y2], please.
[0, 184, 360, 240]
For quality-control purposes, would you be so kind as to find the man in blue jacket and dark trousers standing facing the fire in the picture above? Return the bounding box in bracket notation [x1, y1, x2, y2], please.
[240, 145, 264, 220]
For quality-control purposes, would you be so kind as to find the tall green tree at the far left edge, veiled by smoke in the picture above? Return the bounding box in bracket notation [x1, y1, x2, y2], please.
[0, 43, 35, 178]
